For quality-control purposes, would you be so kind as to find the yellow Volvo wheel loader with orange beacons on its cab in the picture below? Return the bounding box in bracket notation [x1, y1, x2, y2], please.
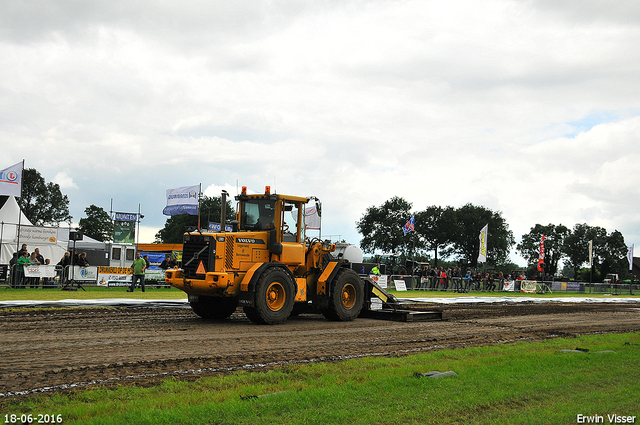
[166, 186, 373, 324]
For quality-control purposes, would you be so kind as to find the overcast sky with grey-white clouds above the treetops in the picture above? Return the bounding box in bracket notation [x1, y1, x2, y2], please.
[0, 0, 640, 264]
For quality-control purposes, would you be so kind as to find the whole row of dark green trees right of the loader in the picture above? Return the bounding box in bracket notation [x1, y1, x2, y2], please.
[356, 196, 628, 281]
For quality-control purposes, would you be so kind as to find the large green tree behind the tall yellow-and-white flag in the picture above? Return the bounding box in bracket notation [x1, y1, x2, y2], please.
[452, 204, 515, 267]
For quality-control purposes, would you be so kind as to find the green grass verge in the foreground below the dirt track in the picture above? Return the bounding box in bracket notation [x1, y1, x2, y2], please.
[0, 333, 640, 425]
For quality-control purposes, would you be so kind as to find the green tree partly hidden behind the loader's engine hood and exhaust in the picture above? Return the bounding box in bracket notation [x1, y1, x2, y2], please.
[156, 195, 234, 243]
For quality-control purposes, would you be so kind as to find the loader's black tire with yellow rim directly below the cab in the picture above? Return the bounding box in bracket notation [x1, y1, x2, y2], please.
[243, 267, 296, 325]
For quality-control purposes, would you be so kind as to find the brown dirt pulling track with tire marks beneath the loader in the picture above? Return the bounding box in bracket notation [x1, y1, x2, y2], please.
[0, 303, 640, 401]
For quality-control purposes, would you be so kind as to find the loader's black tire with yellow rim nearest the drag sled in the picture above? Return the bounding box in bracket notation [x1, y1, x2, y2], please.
[322, 268, 364, 322]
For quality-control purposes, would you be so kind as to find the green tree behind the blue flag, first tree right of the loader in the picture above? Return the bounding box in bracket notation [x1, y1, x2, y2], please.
[356, 196, 413, 253]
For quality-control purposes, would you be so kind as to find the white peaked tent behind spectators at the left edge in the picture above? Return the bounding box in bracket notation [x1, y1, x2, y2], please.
[0, 196, 67, 264]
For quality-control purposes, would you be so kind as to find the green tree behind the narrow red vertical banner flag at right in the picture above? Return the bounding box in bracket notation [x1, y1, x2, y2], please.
[516, 224, 571, 275]
